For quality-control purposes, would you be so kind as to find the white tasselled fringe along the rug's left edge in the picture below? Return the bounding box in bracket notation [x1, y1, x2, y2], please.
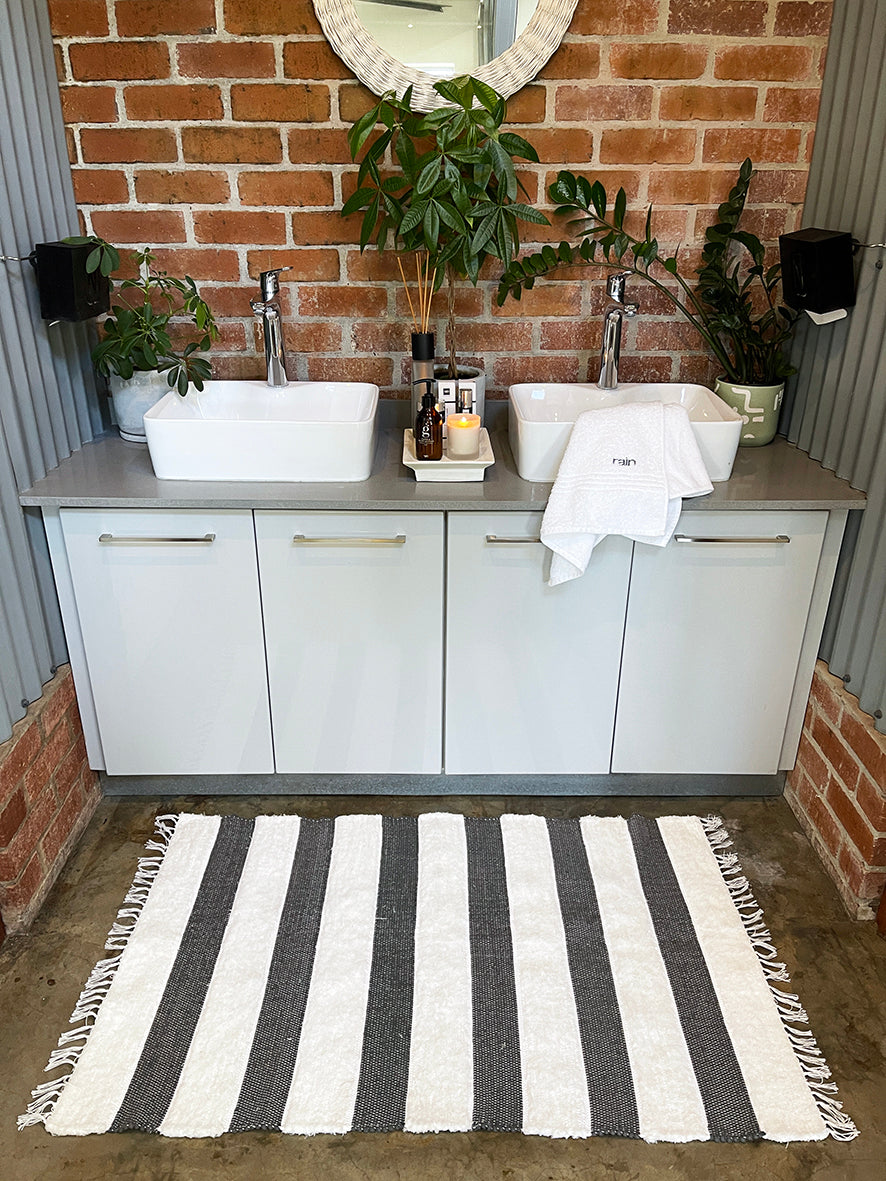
[18, 815, 178, 1131]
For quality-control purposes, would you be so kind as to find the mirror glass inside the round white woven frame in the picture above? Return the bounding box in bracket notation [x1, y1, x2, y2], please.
[353, 0, 538, 78]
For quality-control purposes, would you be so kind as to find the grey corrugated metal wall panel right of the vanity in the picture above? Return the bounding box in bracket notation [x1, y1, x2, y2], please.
[786, 0, 886, 732]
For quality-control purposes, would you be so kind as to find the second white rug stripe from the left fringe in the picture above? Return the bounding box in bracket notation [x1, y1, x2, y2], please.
[158, 816, 300, 1136]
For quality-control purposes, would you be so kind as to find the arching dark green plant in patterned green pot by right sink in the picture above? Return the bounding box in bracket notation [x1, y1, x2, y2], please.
[497, 159, 799, 445]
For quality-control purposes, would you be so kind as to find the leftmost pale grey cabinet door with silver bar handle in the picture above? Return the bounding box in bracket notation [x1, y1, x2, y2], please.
[59, 509, 274, 775]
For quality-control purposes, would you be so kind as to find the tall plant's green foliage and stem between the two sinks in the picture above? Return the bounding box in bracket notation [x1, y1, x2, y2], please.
[341, 76, 548, 394]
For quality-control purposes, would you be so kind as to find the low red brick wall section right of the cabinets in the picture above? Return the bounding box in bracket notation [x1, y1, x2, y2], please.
[784, 660, 886, 919]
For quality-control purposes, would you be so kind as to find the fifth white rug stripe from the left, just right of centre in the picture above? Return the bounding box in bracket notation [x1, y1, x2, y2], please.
[501, 816, 592, 1136]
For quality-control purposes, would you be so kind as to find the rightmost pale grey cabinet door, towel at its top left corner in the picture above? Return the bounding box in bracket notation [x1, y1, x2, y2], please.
[612, 511, 827, 775]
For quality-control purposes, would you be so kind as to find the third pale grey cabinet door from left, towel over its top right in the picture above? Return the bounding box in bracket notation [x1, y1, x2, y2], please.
[445, 513, 631, 775]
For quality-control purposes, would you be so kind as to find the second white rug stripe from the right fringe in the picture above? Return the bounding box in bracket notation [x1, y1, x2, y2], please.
[581, 816, 722, 1143]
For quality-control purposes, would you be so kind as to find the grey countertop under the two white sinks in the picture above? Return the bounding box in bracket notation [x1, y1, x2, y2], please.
[19, 403, 865, 511]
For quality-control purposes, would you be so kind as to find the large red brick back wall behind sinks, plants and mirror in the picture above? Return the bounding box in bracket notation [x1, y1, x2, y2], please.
[48, 0, 832, 393]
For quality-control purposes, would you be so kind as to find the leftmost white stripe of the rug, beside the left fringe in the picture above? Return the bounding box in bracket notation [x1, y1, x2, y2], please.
[46, 815, 221, 1136]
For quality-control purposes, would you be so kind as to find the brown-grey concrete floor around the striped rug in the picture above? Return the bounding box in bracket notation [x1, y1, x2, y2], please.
[0, 796, 886, 1181]
